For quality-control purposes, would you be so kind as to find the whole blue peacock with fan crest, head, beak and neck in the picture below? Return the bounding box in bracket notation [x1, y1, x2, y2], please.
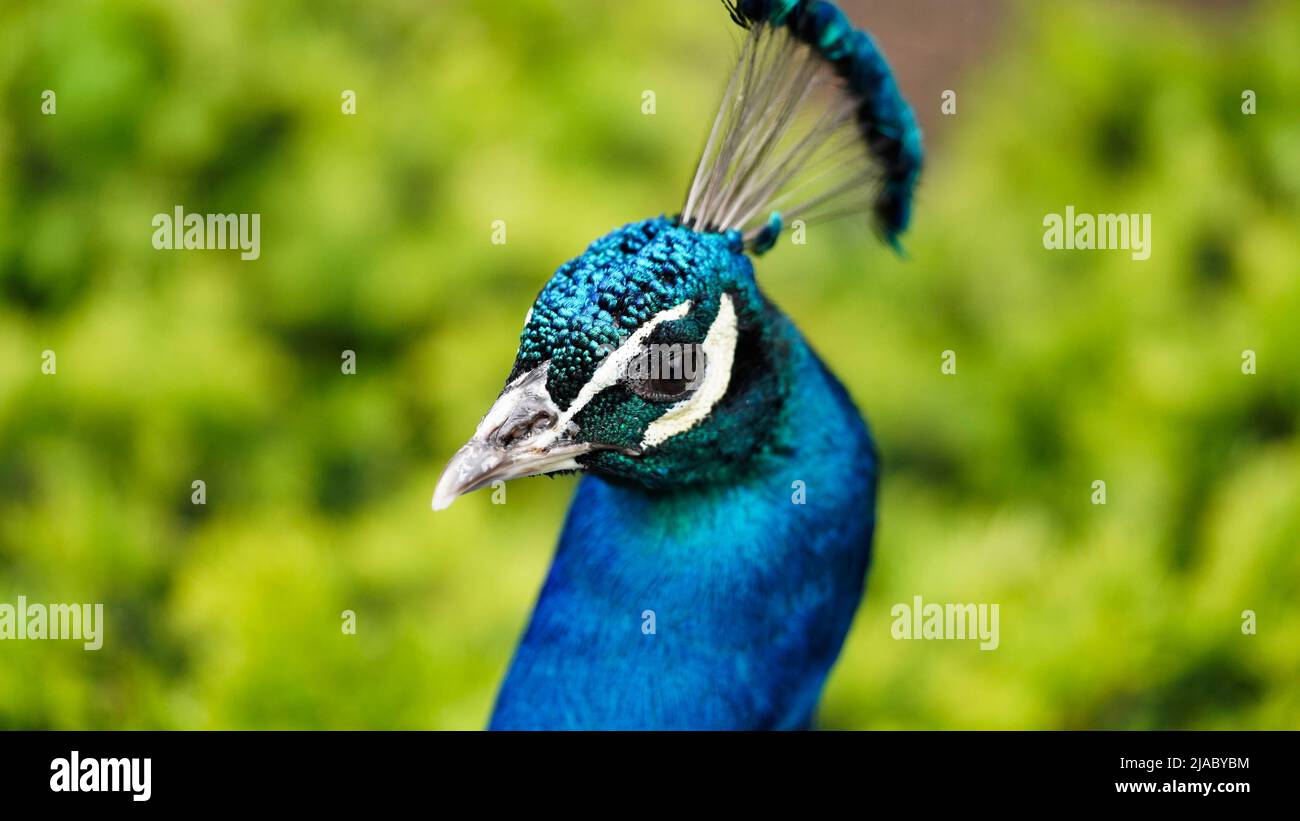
[433, 0, 922, 730]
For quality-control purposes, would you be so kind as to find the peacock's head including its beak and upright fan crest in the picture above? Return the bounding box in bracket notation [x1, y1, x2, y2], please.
[433, 0, 922, 509]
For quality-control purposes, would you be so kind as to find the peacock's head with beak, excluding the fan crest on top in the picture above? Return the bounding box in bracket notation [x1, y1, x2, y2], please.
[433, 217, 783, 509]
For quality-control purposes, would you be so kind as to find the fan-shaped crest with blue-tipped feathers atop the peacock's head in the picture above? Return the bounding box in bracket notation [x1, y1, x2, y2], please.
[681, 0, 922, 253]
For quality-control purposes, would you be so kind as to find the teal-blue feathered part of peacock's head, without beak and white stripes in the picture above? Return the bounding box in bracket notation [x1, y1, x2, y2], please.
[507, 217, 781, 488]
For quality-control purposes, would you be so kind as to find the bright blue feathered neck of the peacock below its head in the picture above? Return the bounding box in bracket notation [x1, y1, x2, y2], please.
[493, 310, 875, 729]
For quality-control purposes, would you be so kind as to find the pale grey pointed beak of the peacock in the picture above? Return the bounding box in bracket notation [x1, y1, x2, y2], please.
[433, 362, 592, 511]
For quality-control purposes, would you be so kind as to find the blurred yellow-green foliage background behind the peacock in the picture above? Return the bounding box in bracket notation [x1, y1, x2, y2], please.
[0, 0, 1300, 729]
